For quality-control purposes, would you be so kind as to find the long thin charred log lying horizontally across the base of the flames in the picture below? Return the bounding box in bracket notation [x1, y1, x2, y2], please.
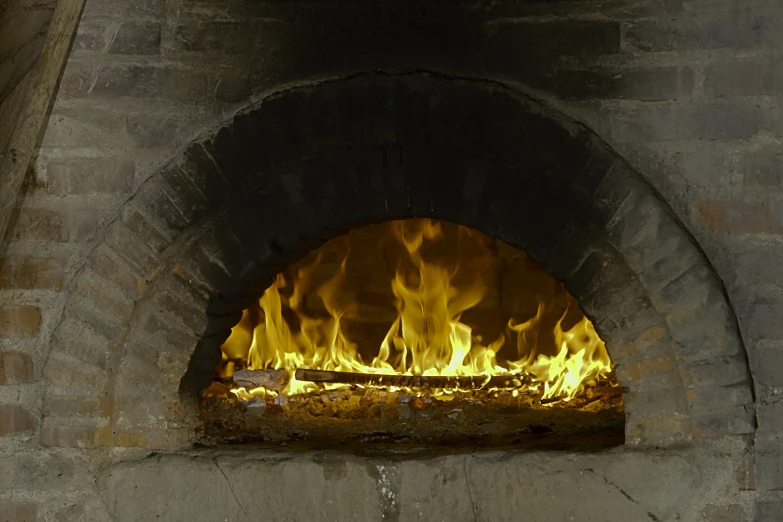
[296, 368, 531, 390]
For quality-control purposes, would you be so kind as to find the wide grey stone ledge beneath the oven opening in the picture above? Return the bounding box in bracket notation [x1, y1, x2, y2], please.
[99, 446, 742, 522]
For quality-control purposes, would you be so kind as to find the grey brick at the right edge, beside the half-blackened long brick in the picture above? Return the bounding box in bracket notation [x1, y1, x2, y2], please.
[704, 56, 783, 96]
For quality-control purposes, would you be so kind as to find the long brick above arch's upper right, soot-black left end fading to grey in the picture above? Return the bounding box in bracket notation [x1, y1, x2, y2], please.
[555, 67, 693, 101]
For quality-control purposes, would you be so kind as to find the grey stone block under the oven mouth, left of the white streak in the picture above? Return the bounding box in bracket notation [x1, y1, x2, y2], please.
[99, 457, 382, 522]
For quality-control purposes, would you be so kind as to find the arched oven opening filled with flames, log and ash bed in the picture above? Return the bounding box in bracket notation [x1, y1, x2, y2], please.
[203, 219, 624, 448]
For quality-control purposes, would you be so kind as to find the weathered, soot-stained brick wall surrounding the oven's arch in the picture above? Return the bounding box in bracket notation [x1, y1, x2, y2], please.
[0, 0, 783, 522]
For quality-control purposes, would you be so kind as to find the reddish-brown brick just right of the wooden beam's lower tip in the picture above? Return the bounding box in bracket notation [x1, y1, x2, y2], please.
[14, 207, 100, 243]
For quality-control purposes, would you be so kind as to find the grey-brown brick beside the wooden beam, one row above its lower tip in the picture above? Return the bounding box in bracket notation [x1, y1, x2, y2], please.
[35, 158, 136, 195]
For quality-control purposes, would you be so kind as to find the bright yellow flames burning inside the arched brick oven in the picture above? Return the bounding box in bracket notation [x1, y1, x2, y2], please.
[219, 219, 614, 400]
